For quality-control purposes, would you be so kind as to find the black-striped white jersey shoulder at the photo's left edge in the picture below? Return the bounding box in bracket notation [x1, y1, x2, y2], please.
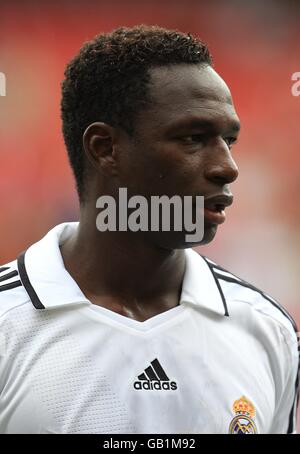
[0, 260, 30, 322]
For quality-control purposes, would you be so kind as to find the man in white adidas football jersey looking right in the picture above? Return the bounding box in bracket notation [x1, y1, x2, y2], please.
[0, 26, 298, 434]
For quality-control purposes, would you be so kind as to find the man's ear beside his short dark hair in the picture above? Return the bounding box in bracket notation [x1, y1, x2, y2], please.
[82, 122, 118, 176]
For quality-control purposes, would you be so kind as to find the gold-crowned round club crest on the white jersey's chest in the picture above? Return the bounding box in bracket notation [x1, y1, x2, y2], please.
[229, 396, 257, 434]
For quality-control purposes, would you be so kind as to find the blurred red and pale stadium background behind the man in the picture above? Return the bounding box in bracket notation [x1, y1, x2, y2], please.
[0, 0, 300, 429]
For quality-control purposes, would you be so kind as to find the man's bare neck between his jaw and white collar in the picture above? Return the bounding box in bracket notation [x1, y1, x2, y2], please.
[61, 210, 185, 308]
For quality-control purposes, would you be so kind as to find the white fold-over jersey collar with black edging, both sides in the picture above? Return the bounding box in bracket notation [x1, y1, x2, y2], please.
[18, 222, 228, 315]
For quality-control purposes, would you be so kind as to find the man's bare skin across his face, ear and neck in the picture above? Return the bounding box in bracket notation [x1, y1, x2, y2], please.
[61, 65, 239, 322]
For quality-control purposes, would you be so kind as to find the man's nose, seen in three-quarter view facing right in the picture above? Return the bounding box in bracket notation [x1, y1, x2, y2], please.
[204, 143, 239, 186]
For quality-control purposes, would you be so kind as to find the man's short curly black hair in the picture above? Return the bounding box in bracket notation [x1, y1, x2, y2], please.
[61, 25, 212, 202]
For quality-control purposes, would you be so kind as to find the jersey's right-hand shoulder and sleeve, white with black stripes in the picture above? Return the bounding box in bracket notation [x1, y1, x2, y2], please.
[202, 256, 300, 422]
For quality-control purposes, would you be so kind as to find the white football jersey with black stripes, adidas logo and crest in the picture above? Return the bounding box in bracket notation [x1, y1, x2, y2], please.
[0, 223, 299, 434]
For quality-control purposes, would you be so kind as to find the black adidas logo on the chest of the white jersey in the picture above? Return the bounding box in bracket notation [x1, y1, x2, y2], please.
[133, 359, 177, 391]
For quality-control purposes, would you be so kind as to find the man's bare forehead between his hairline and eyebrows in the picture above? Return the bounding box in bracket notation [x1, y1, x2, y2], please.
[142, 65, 239, 133]
